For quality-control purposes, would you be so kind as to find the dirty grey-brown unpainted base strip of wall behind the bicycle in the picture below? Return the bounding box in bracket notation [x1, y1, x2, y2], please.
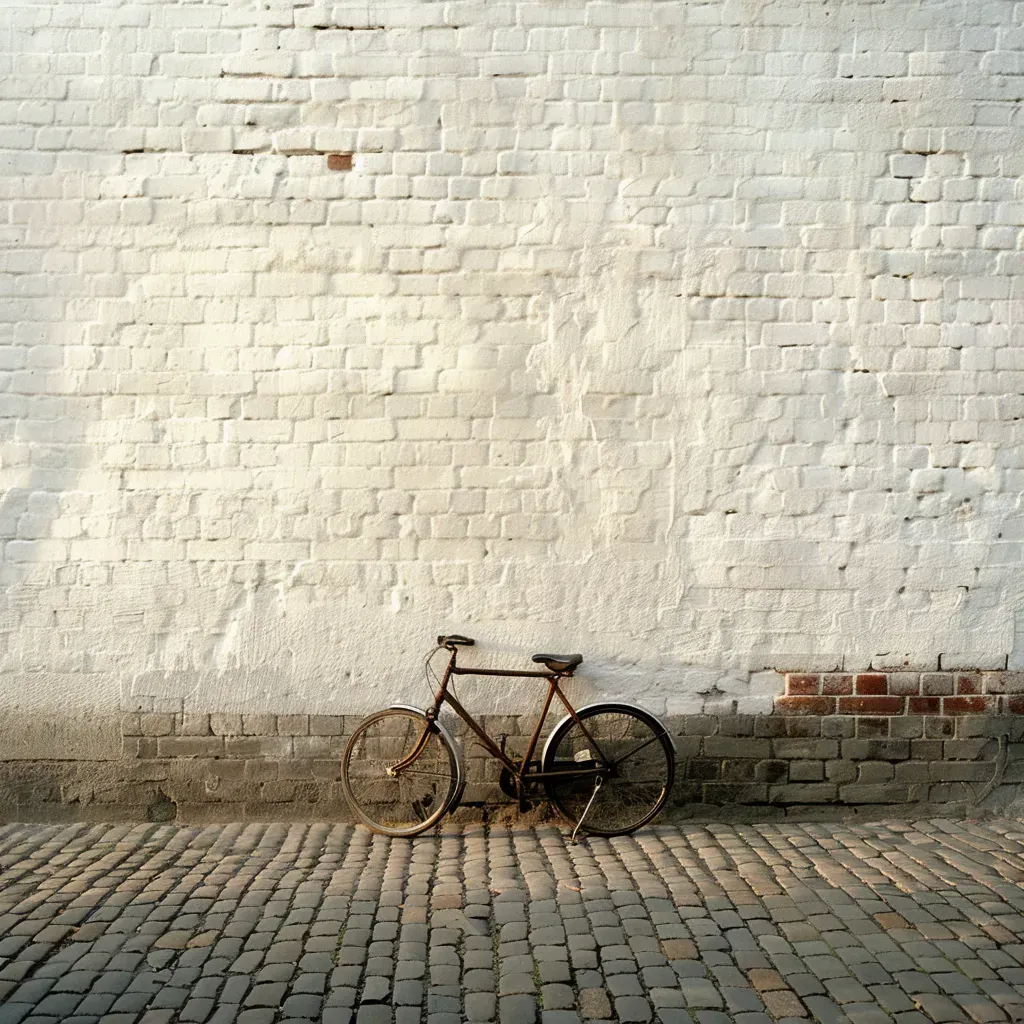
[0, 697, 1024, 823]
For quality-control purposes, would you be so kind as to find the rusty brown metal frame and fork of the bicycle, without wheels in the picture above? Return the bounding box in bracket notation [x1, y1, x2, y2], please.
[389, 646, 610, 784]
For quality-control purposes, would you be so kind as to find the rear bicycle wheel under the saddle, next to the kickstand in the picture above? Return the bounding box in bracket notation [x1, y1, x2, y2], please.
[541, 703, 676, 836]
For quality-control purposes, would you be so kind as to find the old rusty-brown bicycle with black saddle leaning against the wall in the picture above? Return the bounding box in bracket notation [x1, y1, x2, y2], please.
[341, 634, 676, 842]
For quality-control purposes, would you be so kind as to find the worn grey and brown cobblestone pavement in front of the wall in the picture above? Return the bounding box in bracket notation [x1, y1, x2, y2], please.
[0, 820, 1024, 1024]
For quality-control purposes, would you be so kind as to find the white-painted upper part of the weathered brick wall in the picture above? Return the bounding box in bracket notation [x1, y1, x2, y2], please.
[0, 0, 1024, 713]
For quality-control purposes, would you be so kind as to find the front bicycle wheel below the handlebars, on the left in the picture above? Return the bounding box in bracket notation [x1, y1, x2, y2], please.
[341, 708, 459, 839]
